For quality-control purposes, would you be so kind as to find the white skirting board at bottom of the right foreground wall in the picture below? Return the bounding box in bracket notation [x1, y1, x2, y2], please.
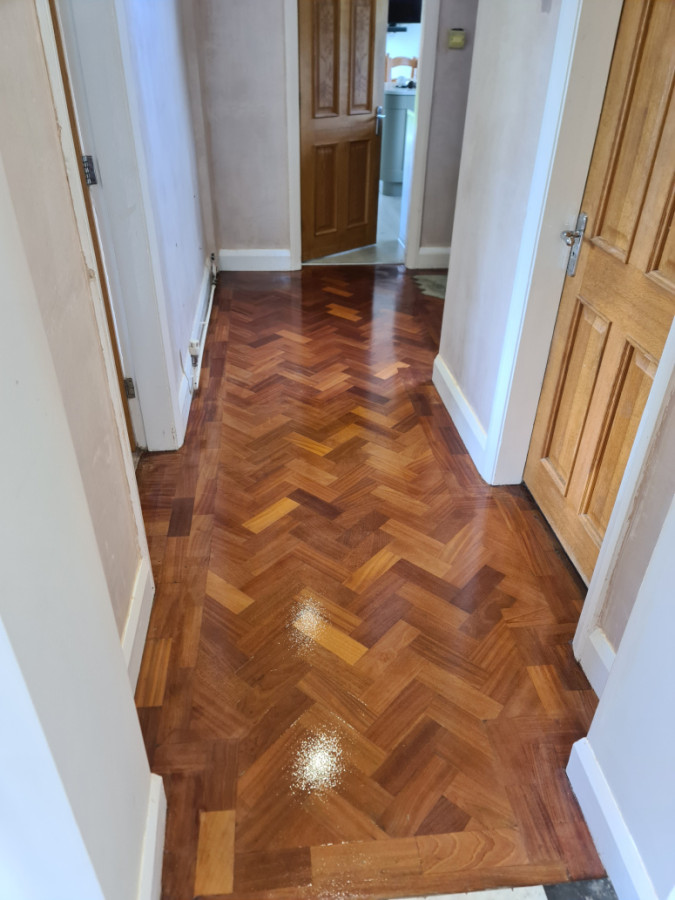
[567, 738, 657, 900]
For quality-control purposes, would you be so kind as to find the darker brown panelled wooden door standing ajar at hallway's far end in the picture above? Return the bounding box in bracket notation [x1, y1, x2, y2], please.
[298, 0, 387, 260]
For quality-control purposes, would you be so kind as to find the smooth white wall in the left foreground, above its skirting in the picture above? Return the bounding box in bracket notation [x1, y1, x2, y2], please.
[0, 151, 159, 900]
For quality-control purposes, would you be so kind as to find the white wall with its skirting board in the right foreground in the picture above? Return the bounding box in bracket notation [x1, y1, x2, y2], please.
[568, 486, 675, 900]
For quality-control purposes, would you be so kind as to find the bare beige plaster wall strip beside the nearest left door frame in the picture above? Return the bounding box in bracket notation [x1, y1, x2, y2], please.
[0, 0, 139, 632]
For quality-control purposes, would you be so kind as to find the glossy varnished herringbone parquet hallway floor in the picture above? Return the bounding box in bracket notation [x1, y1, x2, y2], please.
[136, 266, 603, 900]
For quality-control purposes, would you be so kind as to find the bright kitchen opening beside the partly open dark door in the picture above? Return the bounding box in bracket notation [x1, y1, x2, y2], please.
[301, 0, 433, 265]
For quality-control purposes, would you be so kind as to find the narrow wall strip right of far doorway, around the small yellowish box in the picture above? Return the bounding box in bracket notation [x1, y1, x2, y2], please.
[421, 0, 478, 247]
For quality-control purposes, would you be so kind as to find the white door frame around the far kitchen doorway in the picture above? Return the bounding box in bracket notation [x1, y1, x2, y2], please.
[284, 0, 441, 270]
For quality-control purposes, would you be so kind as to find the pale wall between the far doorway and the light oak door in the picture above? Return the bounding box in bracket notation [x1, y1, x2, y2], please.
[439, 0, 561, 429]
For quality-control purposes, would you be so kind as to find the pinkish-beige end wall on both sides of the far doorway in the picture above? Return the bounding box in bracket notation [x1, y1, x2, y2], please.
[183, 0, 470, 250]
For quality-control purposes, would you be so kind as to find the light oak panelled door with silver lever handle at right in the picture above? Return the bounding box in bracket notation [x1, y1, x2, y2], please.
[525, 0, 675, 581]
